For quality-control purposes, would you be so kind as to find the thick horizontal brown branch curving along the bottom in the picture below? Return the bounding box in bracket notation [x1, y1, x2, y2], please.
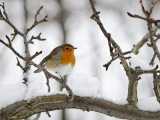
[0, 95, 160, 120]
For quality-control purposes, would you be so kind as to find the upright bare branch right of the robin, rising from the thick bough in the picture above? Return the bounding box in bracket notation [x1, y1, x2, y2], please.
[89, 0, 138, 106]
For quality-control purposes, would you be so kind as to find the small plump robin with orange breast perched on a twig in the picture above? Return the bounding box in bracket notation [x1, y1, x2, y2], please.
[34, 44, 77, 94]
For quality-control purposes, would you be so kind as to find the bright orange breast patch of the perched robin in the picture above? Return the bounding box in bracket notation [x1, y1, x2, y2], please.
[61, 51, 75, 66]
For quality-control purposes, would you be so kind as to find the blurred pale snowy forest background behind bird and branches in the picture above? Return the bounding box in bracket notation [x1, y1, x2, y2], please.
[0, 0, 160, 120]
